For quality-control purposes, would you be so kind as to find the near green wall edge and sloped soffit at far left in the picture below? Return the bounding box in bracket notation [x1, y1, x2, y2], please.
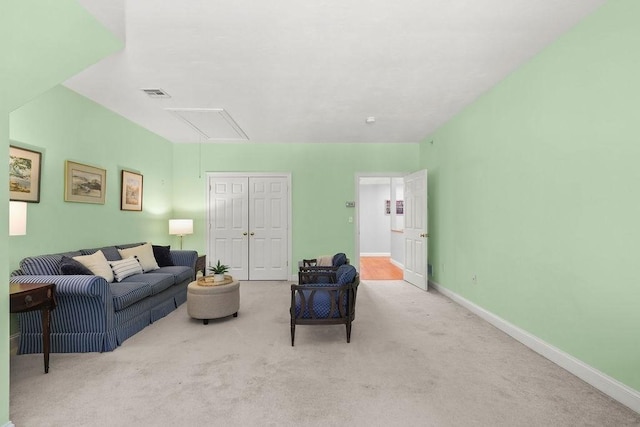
[0, 0, 122, 425]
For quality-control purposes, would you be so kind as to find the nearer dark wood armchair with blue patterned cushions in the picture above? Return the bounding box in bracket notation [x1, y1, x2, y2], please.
[290, 264, 360, 346]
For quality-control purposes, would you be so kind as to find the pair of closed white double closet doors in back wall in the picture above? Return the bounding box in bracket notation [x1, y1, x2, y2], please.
[207, 173, 291, 280]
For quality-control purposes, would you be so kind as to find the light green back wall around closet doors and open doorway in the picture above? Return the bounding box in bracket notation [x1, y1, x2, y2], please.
[173, 143, 419, 268]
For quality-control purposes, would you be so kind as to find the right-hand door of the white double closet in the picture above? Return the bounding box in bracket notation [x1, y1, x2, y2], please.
[249, 177, 289, 280]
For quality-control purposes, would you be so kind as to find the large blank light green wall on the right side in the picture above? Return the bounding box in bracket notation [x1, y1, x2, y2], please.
[421, 0, 640, 390]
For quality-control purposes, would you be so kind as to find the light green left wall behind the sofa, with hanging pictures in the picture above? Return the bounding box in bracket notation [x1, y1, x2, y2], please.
[10, 86, 178, 268]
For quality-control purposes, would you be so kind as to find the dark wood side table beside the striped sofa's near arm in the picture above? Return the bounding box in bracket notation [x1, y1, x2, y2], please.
[10, 283, 56, 374]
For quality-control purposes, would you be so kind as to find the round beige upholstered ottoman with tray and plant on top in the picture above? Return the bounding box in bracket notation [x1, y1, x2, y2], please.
[187, 276, 240, 325]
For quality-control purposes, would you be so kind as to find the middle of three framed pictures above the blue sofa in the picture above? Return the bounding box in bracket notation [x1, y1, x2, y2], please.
[64, 160, 107, 205]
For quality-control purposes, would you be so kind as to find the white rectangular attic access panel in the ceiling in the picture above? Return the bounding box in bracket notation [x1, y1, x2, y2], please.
[167, 108, 249, 141]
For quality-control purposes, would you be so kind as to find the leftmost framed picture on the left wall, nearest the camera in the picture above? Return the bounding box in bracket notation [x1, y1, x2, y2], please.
[9, 145, 42, 203]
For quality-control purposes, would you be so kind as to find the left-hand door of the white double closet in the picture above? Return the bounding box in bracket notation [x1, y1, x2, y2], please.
[208, 177, 249, 280]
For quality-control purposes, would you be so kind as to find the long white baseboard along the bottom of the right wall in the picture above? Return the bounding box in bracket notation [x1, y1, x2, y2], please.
[429, 281, 640, 413]
